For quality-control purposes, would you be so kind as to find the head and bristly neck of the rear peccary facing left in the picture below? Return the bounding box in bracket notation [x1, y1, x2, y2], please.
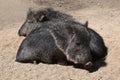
[18, 8, 72, 36]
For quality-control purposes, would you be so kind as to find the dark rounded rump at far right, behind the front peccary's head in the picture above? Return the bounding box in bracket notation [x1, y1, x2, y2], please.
[88, 28, 108, 61]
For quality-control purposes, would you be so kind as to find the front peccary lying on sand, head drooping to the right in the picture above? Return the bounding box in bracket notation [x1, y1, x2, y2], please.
[16, 20, 92, 68]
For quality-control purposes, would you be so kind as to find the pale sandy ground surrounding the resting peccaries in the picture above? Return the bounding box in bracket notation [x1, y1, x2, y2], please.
[0, 0, 120, 80]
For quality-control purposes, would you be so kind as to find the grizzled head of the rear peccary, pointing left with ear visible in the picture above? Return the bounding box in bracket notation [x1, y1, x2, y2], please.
[18, 9, 48, 36]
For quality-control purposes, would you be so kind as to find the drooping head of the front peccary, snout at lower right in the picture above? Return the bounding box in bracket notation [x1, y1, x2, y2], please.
[49, 22, 92, 68]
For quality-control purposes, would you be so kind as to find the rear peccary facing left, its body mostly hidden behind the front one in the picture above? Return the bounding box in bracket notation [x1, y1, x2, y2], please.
[18, 8, 107, 60]
